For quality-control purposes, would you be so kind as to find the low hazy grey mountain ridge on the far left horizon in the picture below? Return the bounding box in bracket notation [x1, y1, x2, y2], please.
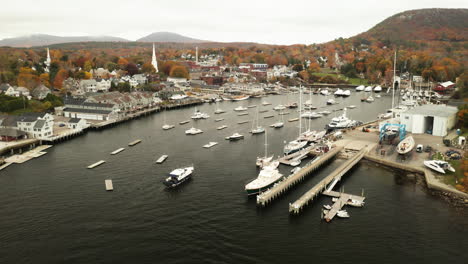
[0, 34, 129, 47]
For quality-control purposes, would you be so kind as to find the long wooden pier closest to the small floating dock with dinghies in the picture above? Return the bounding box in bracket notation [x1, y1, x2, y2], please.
[289, 148, 367, 214]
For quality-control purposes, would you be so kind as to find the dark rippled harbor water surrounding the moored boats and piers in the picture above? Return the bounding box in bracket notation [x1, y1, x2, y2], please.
[0, 92, 468, 263]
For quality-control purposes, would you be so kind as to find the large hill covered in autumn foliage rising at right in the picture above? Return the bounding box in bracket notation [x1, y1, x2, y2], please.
[356, 8, 468, 43]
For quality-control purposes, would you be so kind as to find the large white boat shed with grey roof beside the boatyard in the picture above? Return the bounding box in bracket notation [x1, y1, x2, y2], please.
[400, 104, 458, 137]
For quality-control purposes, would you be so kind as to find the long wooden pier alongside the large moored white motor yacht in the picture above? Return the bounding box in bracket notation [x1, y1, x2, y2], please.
[257, 146, 343, 206]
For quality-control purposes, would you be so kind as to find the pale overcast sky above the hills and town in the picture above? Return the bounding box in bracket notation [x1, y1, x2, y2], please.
[0, 0, 468, 44]
